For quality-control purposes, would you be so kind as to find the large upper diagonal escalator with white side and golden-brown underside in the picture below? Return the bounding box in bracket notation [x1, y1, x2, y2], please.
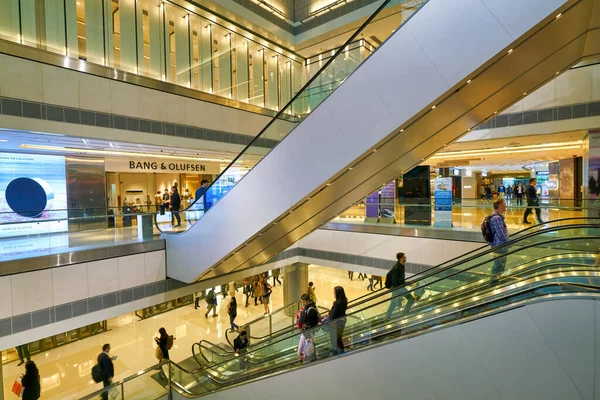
[159, 0, 600, 282]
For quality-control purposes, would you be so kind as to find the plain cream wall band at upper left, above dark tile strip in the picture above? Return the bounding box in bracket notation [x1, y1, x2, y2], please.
[0, 54, 271, 140]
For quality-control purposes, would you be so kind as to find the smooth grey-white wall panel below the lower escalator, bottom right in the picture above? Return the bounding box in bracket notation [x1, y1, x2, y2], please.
[204, 299, 600, 400]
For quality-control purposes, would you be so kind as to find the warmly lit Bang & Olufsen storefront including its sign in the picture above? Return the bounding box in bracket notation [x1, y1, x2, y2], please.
[105, 158, 221, 212]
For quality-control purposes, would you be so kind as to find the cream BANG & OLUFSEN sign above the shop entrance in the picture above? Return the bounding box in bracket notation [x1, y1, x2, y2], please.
[104, 158, 221, 175]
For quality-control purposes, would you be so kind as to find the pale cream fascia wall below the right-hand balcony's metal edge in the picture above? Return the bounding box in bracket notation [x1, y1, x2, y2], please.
[295, 229, 483, 271]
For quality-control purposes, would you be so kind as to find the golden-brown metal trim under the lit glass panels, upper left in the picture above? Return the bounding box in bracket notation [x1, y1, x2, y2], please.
[0, 39, 290, 118]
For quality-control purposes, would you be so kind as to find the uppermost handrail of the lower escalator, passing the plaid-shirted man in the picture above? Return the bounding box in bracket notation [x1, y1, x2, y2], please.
[225, 217, 600, 347]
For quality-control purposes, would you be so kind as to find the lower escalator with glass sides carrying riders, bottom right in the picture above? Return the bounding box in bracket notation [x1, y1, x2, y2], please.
[157, 221, 600, 398]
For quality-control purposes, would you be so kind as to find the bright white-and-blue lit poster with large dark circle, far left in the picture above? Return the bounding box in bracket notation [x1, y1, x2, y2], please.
[0, 153, 69, 237]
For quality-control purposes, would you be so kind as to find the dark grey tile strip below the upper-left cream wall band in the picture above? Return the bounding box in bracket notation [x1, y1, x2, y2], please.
[0, 97, 278, 149]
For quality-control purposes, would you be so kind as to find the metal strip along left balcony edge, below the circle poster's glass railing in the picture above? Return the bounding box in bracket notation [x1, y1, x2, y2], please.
[0, 239, 165, 276]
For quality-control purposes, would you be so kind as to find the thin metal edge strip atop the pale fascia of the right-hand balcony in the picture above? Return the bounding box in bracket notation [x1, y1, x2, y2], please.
[319, 222, 485, 243]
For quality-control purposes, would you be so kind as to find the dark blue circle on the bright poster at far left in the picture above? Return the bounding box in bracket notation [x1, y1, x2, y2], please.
[5, 178, 54, 218]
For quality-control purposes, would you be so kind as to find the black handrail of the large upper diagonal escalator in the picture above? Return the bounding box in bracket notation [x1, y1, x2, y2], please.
[154, 0, 429, 234]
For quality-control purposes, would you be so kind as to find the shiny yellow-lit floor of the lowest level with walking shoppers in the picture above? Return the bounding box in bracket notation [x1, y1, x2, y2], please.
[3, 265, 376, 400]
